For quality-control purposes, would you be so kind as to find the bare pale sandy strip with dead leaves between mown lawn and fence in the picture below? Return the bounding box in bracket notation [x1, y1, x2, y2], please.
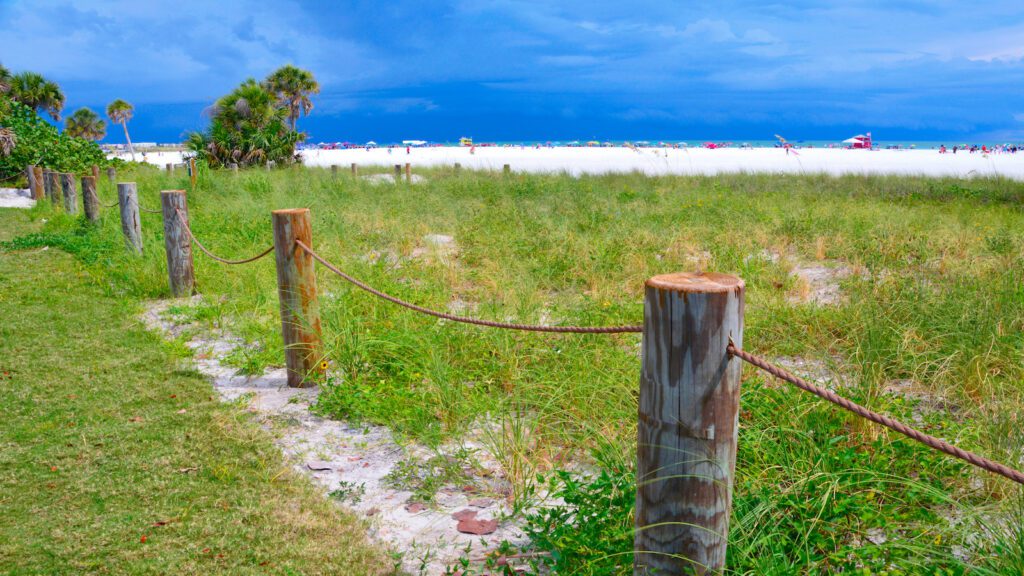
[142, 297, 525, 574]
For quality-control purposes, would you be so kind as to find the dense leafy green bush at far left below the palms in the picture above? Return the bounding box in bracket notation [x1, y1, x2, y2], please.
[0, 98, 110, 179]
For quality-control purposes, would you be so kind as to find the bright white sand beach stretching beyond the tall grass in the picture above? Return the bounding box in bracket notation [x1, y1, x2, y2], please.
[114, 147, 1024, 180]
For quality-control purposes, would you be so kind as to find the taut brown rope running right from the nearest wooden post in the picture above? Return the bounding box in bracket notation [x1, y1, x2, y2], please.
[728, 341, 1024, 485]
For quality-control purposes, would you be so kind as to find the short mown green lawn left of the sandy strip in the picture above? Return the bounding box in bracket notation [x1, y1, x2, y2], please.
[0, 210, 389, 574]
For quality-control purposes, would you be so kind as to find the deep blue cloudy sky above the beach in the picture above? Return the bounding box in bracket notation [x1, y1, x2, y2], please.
[0, 0, 1024, 141]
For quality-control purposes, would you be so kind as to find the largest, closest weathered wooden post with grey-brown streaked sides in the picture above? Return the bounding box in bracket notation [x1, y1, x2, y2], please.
[634, 273, 743, 576]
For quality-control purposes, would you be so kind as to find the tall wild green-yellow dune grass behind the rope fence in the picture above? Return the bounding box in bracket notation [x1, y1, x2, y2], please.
[13, 163, 1024, 574]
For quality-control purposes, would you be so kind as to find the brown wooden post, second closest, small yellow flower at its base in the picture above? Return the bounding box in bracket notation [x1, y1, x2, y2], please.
[272, 208, 324, 387]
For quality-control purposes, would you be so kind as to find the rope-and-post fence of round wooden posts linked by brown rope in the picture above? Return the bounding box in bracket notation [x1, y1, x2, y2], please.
[28, 163, 1024, 574]
